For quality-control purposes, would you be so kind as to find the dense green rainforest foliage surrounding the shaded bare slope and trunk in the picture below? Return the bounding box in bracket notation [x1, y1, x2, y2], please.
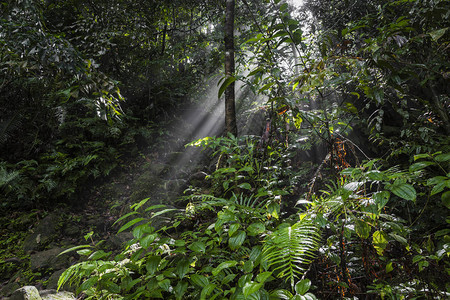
[0, 0, 450, 299]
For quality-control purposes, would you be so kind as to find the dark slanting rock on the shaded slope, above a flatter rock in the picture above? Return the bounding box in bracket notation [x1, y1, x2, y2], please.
[23, 213, 61, 252]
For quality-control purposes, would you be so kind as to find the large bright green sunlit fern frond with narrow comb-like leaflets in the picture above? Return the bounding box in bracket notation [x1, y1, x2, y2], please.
[262, 218, 320, 287]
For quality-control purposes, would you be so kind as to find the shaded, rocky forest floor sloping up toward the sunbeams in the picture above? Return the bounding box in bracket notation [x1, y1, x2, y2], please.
[0, 108, 214, 299]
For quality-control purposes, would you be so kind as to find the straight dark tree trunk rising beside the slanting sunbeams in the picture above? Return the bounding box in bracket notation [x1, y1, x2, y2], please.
[225, 0, 237, 136]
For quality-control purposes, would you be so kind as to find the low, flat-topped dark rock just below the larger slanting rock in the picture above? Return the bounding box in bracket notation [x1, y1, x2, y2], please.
[30, 248, 70, 272]
